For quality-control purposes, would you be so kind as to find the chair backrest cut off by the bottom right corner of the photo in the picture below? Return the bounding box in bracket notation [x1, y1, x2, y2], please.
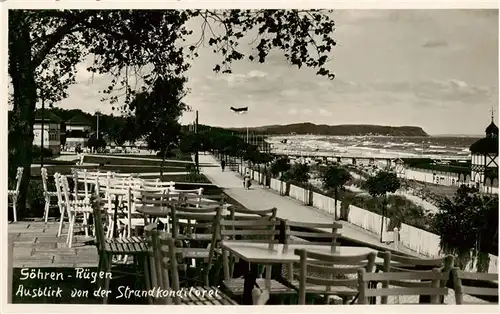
[452, 268, 498, 304]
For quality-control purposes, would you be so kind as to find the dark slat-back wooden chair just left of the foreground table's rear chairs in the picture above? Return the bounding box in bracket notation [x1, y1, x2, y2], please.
[171, 205, 221, 285]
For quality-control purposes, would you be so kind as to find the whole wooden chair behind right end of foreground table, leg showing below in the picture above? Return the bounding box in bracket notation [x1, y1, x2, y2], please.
[283, 220, 342, 289]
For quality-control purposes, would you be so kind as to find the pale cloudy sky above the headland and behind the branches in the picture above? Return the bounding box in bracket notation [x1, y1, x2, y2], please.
[49, 9, 499, 135]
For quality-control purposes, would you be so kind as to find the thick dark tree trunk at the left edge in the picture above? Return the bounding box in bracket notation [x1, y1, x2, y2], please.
[9, 10, 37, 219]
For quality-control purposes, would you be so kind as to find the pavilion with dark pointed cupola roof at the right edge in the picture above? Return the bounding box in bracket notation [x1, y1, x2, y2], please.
[469, 115, 498, 188]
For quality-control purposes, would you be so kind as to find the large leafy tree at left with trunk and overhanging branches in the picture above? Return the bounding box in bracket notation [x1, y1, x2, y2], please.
[8, 10, 335, 216]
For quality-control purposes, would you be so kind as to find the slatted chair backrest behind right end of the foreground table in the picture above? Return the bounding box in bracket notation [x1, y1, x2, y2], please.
[284, 220, 342, 253]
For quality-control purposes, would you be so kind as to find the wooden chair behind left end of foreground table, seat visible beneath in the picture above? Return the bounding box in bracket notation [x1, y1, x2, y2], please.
[220, 217, 296, 296]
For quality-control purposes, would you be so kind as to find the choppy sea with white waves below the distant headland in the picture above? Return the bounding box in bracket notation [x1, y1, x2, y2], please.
[266, 135, 481, 160]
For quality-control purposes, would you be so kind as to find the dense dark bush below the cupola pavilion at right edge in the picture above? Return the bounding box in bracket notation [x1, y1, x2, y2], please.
[434, 185, 498, 271]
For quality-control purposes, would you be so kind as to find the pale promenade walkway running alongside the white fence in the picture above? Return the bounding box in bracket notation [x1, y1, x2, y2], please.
[195, 155, 419, 256]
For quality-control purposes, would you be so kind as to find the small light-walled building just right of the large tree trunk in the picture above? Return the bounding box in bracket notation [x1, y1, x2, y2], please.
[33, 110, 62, 155]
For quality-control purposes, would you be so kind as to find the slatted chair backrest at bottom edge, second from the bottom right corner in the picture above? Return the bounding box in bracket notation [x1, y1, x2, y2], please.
[358, 268, 449, 304]
